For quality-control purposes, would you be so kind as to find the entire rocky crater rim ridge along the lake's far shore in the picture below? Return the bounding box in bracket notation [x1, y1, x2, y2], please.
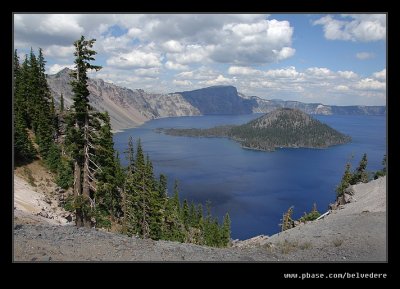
[47, 68, 386, 130]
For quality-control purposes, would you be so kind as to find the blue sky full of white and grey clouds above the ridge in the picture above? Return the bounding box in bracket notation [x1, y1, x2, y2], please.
[13, 14, 387, 105]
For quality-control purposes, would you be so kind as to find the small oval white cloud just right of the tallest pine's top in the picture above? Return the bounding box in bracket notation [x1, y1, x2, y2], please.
[107, 50, 161, 69]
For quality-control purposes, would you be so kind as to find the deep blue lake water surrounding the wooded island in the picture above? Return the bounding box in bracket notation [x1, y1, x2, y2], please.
[114, 114, 386, 239]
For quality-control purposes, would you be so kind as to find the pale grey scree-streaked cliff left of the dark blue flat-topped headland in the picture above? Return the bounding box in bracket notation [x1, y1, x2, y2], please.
[47, 68, 200, 130]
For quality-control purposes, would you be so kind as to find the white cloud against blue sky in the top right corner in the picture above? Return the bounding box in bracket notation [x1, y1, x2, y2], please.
[313, 14, 386, 42]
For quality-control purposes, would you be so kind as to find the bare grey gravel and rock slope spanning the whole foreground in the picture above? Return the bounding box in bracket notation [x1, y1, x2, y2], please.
[14, 164, 387, 262]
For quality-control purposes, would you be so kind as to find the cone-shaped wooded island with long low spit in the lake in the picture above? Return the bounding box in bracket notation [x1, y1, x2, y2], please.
[156, 108, 351, 151]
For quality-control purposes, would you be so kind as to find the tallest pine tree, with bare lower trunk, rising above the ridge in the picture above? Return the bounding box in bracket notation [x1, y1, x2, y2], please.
[67, 36, 101, 227]
